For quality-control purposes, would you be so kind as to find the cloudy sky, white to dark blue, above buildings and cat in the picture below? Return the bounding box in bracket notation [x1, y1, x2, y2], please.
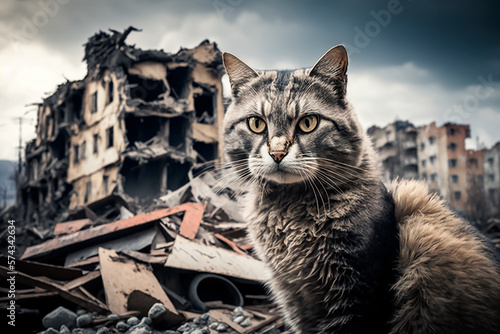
[0, 0, 500, 160]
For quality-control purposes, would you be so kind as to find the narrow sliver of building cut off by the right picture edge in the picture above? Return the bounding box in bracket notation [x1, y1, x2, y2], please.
[483, 142, 500, 214]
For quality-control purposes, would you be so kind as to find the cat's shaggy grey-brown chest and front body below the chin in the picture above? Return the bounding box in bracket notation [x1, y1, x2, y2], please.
[248, 183, 395, 333]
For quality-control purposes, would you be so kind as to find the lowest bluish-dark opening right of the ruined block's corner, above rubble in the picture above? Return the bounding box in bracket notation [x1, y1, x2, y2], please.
[120, 159, 168, 198]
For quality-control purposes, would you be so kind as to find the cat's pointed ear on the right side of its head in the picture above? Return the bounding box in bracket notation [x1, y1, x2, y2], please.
[309, 45, 348, 92]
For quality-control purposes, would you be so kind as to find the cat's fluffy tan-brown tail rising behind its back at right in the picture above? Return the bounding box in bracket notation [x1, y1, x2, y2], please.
[391, 180, 500, 334]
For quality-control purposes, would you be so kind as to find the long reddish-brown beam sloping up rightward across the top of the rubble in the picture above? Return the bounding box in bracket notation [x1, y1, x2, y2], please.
[21, 203, 203, 259]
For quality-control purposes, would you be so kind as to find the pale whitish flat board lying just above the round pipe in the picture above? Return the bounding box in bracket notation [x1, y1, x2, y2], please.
[165, 236, 267, 281]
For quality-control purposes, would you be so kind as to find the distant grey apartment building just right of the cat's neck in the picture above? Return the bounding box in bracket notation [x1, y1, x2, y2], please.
[367, 121, 418, 183]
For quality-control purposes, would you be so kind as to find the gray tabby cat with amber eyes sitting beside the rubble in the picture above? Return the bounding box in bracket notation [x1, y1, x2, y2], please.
[223, 46, 500, 333]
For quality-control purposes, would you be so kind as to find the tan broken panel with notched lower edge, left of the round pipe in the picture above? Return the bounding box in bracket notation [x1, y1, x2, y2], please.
[99, 248, 182, 322]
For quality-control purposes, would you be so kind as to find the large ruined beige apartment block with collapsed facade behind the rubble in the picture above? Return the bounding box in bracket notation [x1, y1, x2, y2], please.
[18, 27, 224, 229]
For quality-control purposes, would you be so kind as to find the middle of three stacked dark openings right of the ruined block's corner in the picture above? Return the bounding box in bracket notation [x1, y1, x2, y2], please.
[125, 114, 162, 145]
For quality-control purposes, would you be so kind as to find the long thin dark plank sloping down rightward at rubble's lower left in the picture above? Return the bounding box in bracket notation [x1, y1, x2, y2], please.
[0, 266, 109, 313]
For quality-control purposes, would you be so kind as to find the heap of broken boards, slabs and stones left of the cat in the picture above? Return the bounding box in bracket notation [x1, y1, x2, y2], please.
[0, 172, 283, 334]
